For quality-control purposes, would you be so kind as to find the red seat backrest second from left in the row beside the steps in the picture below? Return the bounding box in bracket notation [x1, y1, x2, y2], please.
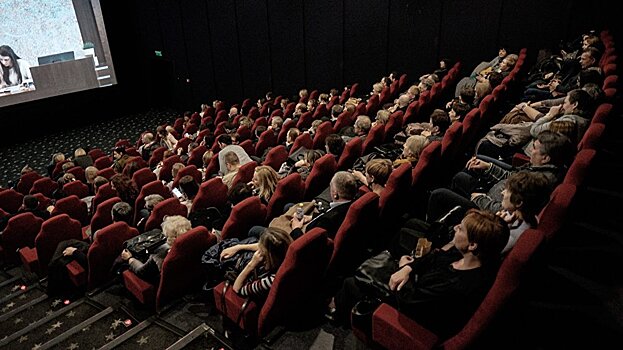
[35, 214, 82, 274]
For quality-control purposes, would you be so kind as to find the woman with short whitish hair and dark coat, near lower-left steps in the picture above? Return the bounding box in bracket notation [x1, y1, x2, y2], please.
[121, 215, 191, 284]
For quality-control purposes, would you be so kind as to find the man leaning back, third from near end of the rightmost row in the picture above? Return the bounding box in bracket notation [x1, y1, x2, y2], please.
[427, 130, 573, 224]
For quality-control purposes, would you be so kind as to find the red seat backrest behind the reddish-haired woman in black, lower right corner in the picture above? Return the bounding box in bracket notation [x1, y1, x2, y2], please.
[441, 229, 544, 349]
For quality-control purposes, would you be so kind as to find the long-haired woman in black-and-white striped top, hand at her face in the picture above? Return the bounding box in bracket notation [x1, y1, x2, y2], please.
[233, 227, 292, 298]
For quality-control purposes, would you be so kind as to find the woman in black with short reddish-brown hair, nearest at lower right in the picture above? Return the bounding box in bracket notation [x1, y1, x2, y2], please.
[334, 210, 509, 338]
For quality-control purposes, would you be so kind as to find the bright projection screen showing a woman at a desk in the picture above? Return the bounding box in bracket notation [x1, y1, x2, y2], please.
[0, 0, 117, 107]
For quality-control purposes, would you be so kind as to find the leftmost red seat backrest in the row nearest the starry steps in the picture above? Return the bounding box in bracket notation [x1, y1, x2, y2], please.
[2, 213, 43, 262]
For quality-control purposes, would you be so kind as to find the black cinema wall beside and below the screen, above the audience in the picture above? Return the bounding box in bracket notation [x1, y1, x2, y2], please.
[0, 0, 621, 146]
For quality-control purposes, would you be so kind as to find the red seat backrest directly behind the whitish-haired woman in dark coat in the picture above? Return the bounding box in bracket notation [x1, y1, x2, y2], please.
[156, 226, 216, 310]
